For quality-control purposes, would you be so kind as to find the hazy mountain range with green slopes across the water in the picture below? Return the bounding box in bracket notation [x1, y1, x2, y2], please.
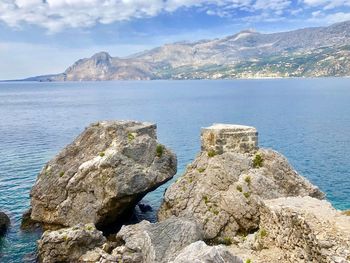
[25, 21, 350, 81]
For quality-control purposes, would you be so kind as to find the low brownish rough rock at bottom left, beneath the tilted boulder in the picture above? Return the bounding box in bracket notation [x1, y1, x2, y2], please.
[38, 224, 106, 263]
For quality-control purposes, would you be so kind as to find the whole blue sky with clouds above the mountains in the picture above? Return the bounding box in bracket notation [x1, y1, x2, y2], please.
[0, 0, 350, 80]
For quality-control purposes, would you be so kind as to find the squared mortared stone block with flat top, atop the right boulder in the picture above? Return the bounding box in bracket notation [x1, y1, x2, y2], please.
[201, 124, 258, 154]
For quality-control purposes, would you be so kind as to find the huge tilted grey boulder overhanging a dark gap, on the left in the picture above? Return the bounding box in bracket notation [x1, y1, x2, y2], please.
[27, 121, 177, 228]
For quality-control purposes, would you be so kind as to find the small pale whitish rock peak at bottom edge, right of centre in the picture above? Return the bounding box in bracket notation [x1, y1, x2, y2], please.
[171, 241, 243, 263]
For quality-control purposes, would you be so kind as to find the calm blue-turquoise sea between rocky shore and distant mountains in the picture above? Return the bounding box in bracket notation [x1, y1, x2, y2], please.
[0, 79, 350, 262]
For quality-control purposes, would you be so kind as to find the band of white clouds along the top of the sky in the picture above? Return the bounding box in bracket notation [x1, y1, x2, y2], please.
[0, 0, 350, 32]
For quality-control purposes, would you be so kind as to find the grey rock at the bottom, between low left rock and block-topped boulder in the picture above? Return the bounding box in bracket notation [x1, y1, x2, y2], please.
[80, 217, 203, 263]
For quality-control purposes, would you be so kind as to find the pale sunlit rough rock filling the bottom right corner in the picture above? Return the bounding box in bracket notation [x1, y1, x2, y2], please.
[257, 197, 350, 263]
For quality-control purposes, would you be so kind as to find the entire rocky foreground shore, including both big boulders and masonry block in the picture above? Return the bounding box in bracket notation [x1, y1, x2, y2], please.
[18, 121, 350, 263]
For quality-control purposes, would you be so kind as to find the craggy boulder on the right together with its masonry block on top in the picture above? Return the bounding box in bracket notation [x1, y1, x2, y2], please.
[158, 124, 324, 242]
